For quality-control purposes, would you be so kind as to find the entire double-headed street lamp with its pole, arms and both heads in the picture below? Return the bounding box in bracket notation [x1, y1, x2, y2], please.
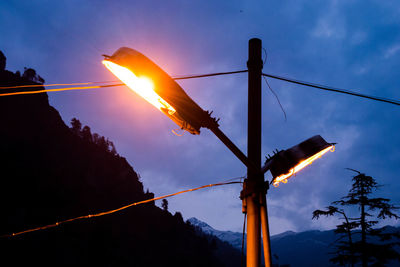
[103, 39, 333, 267]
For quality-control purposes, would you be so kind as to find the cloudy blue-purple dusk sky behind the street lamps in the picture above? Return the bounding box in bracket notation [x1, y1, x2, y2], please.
[0, 0, 400, 234]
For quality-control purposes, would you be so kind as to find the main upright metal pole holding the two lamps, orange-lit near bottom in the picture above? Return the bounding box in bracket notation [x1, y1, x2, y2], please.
[245, 38, 264, 267]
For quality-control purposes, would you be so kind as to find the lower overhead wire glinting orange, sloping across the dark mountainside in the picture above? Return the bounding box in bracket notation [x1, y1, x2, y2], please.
[0, 177, 243, 238]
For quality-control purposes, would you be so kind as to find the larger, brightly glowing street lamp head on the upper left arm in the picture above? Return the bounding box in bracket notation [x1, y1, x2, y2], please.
[103, 47, 218, 134]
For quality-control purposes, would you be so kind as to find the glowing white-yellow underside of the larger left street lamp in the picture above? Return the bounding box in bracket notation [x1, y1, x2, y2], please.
[102, 60, 176, 115]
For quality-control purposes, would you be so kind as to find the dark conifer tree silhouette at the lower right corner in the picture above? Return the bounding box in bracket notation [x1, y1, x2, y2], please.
[312, 169, 400, 267]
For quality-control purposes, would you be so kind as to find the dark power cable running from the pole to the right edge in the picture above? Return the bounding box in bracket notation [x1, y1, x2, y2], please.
[262, 73, 400, 106]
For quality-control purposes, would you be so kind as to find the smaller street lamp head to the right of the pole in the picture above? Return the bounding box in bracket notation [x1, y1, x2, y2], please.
[269, 135, 335, 187]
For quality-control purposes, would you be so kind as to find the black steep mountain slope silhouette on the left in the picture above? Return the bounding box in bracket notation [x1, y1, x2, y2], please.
[0, 54, 240, 266]
